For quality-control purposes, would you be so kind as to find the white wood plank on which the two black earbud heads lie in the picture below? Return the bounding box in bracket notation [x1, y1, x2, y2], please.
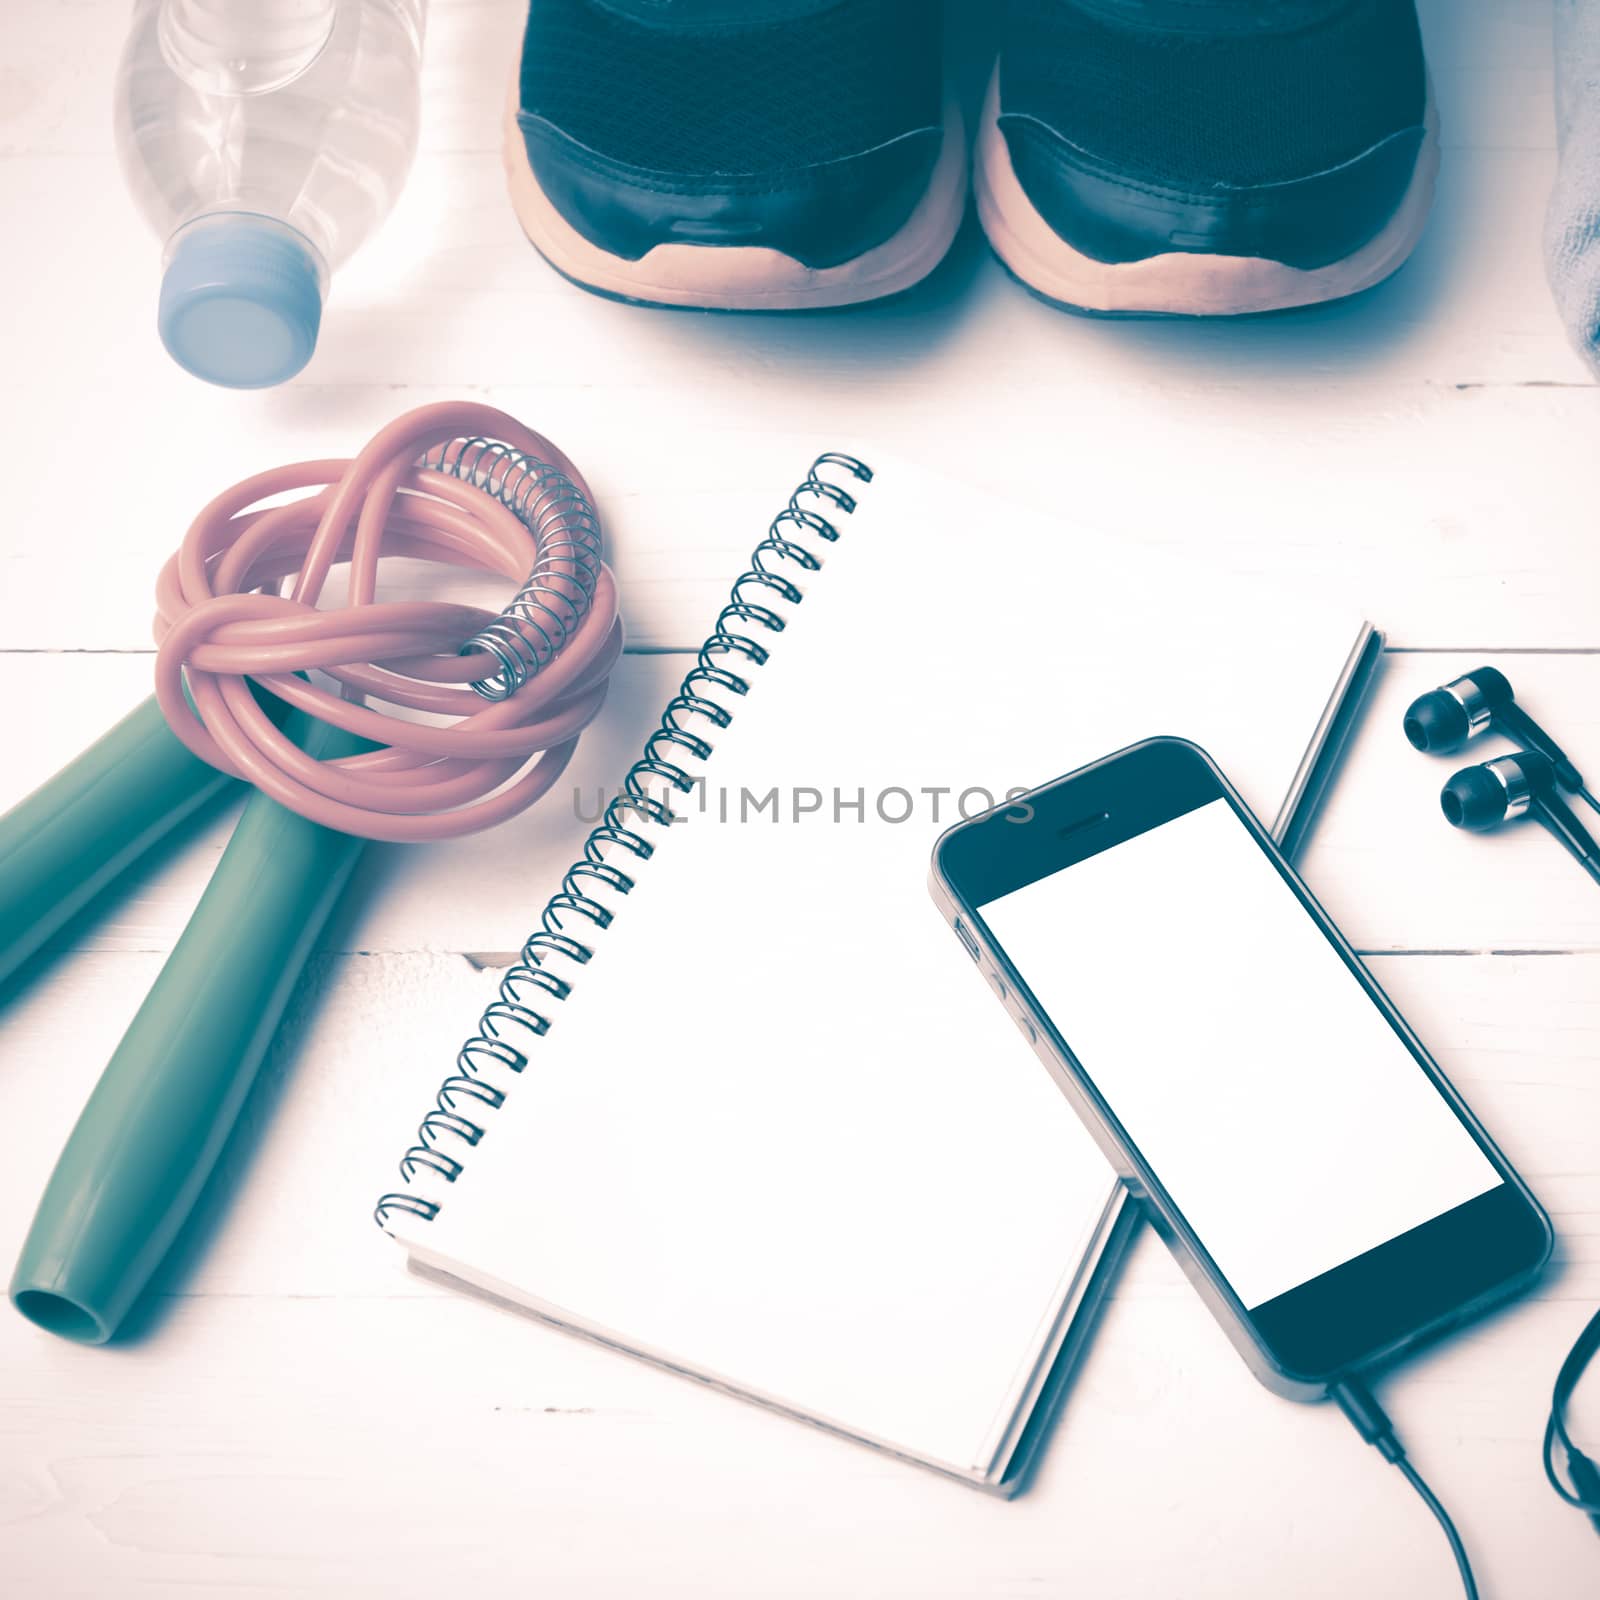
[0, 651, 1600, 952]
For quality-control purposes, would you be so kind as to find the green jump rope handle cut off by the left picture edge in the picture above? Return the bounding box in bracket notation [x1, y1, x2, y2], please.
[0, 694, 286, 982]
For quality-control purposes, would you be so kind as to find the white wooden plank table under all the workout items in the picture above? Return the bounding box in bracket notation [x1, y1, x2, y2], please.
[0, 0, 1600, 1600]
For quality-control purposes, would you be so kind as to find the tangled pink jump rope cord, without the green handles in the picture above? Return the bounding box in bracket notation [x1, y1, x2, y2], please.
[155, 402, 622, 843]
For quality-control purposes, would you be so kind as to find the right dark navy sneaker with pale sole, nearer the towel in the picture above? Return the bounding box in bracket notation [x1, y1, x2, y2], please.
[974, 0, 1438, 315]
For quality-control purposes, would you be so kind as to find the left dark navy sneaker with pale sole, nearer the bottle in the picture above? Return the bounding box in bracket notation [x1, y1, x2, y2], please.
[506, 0, 966, 310]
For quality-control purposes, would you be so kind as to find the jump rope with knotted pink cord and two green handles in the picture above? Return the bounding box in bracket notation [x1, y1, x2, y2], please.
[0, 403, 622, 1344]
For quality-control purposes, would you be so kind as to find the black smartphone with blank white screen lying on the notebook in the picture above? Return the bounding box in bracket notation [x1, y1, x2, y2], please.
[931, 739, 1552, 1400]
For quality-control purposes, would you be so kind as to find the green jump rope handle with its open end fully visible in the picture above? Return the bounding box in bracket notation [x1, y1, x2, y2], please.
[11, 712, 373, 1344]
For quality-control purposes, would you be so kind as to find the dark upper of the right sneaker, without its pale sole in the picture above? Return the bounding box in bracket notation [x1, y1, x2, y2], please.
[1000, 0, 1426, 266]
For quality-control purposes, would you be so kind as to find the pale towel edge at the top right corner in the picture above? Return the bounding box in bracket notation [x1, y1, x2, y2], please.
[1544, 0, 1600, 373]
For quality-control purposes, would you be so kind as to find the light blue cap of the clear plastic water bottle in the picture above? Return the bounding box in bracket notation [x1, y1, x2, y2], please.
[157, 213, 322, 389]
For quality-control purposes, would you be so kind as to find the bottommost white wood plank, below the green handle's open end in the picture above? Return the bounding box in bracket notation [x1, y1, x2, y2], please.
[0, 1298, 1595, 1600]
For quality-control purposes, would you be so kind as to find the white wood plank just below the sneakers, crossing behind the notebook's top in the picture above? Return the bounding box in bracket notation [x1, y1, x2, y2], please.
[0, 374, 1600, 650]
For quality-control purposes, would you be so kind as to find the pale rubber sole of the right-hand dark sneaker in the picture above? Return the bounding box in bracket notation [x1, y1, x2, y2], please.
[973, 66, 1438, 317]
